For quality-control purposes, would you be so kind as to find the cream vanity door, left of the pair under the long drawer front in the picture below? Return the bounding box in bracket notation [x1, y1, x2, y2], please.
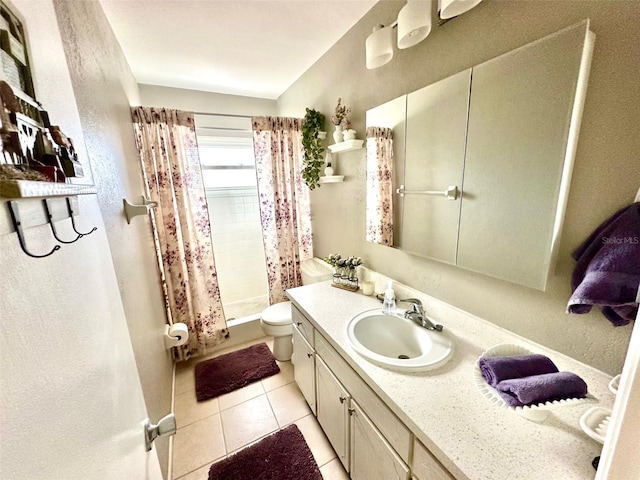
[316, 357, 349, 471]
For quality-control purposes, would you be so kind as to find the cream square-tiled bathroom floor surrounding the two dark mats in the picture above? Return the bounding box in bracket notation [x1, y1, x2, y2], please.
[172, 337, 349, 480]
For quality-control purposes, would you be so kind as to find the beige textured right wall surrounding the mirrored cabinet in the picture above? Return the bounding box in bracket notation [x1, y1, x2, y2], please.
[278, 0, 640, 374]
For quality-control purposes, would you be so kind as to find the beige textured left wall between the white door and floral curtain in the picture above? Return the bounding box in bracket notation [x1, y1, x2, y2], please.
[54, 0, 173, 477]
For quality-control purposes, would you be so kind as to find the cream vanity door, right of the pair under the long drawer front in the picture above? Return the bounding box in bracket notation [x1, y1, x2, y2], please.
[349, 400, 409, 480]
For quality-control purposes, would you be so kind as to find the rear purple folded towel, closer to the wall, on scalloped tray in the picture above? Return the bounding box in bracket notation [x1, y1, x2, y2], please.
[478, 354, 558, 387]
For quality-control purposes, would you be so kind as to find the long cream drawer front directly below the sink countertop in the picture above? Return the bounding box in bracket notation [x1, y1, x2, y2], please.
[315, 333, 411, 463]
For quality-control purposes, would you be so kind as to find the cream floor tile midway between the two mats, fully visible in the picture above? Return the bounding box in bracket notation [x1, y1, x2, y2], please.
[220, 395, 278, 453]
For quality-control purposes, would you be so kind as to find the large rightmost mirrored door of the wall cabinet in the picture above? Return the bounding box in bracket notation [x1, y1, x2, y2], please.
[458, 23, 590, 290]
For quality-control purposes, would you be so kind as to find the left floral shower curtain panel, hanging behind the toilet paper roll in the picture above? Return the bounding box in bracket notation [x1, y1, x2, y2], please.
[131, 107, 228, 360]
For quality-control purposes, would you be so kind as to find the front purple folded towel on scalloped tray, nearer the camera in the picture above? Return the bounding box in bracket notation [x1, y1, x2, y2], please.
[495, 372, 587, 407]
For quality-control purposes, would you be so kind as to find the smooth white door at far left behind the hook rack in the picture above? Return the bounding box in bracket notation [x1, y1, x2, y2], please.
[0, 0, 162, 480]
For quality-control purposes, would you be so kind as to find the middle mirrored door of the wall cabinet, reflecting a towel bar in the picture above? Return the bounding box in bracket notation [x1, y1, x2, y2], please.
[399, 70, 471, 265]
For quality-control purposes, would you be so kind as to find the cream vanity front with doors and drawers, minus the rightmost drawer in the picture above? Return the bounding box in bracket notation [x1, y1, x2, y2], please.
[292, 306, 420, 480]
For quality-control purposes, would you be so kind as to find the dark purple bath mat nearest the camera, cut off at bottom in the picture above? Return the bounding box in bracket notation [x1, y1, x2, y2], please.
[209, 424, 322, 480]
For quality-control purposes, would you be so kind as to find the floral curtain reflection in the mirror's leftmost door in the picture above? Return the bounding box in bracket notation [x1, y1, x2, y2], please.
[366, 127, 393, 246]
